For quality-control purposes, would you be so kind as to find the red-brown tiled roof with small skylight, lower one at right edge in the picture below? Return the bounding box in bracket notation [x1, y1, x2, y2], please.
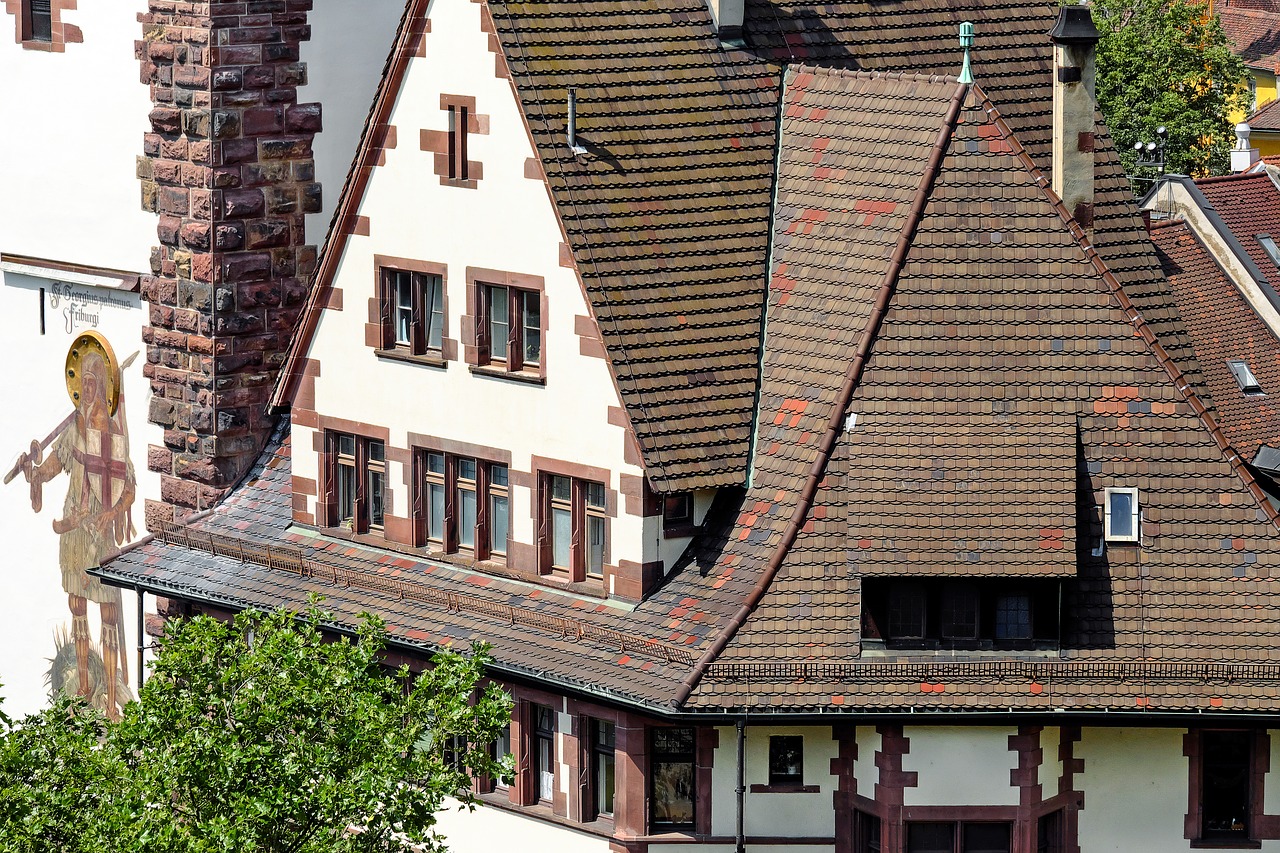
[1151, 220, 1280, 459]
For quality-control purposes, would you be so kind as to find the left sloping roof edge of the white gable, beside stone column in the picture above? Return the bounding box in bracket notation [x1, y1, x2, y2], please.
[269, 0, 429, 407]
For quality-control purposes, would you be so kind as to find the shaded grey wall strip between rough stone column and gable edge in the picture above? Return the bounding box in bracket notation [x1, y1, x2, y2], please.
[298, 0, 404, 246]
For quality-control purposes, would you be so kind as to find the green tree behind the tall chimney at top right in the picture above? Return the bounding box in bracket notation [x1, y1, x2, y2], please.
[1093, 0, 1248, 175]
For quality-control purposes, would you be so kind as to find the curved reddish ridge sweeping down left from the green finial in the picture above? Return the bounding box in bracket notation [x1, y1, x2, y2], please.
[672, 83, 972, 707]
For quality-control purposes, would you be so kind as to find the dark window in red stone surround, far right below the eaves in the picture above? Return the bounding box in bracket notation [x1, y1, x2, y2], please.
[1192, 730, 1261, 844]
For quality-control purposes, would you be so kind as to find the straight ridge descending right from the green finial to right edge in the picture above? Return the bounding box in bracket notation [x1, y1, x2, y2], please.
[974, 83, 1280, 528]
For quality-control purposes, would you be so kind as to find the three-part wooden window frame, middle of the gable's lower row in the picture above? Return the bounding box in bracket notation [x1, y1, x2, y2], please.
[412, 447, 511, 564]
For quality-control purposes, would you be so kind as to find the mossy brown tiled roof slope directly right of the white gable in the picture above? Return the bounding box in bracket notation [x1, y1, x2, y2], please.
[489, 0, 778, 491]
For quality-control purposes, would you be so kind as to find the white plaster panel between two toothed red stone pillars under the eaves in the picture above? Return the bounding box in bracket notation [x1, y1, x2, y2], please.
[902, 726, 1018, 806]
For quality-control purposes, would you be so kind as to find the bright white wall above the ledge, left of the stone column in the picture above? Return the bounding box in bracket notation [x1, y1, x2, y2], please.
[0, 0, 155, 272]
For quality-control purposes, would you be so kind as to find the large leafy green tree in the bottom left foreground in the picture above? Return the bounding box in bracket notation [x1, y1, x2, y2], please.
[0, 607, 511, 853]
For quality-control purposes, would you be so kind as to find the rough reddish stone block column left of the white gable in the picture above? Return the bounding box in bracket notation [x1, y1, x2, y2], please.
[136, 0, 321, 524]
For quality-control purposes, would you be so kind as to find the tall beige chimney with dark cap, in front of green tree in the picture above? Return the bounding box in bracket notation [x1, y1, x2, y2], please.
[1048, 3, 1101, 229]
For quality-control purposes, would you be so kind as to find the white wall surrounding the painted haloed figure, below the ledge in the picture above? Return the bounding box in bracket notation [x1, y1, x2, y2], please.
[0, 268, 160, 716]
